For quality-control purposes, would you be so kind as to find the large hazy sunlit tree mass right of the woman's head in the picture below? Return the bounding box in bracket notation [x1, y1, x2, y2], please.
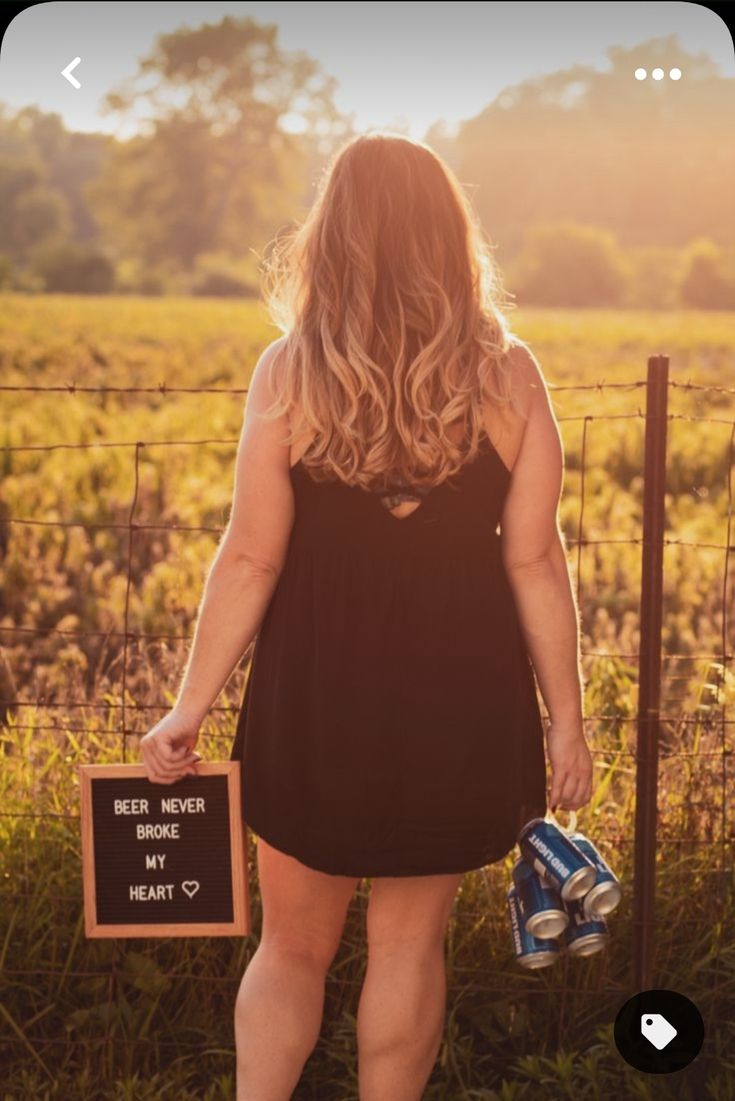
[451, 35, 735, 258]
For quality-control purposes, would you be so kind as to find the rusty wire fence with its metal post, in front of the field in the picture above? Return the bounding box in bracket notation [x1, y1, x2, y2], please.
[0, 357, 735, 1074]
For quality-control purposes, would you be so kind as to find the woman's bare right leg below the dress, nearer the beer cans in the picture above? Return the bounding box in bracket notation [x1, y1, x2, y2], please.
[358, 875, 462, 1101]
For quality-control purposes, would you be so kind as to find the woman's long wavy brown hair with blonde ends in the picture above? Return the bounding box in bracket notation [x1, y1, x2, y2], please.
[258, 131, 523, 489]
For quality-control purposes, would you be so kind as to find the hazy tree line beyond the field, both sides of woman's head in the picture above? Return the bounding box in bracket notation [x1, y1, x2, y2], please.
[0, 17, 735, 308]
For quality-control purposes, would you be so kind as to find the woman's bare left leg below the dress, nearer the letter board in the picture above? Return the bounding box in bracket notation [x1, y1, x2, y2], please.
[234, 838, 360, 1101]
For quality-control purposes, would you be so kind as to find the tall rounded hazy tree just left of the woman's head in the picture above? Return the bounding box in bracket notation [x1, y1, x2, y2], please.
[88, 17, 344, 271]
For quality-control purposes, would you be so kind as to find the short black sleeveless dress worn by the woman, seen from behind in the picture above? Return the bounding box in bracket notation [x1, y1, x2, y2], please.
[231, 424, 546, 876]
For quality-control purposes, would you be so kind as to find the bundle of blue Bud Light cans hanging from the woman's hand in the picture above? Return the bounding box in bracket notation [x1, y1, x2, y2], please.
[507, 818, 622, 969]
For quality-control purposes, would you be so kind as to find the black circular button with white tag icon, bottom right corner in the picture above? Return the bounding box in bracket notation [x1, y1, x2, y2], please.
[614, 990, 704, 1075]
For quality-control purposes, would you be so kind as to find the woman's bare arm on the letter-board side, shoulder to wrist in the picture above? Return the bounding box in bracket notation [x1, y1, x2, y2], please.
[175, 338, 294, 723]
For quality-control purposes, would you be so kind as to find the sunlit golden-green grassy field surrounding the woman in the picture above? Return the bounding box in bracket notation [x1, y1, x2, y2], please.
[0, 295, 735, 1101]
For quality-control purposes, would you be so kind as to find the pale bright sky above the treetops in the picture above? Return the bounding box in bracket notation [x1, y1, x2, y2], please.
[0, 0, 735, 139]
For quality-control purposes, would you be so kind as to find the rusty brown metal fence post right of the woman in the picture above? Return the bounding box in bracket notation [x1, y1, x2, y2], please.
[633, 356, 669, 991]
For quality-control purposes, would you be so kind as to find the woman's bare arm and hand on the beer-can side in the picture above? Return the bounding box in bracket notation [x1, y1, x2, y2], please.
[501, 346, 591, 809]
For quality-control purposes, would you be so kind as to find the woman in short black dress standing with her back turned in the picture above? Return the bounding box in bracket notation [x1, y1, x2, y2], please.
[143, 133, 592, 1101]
